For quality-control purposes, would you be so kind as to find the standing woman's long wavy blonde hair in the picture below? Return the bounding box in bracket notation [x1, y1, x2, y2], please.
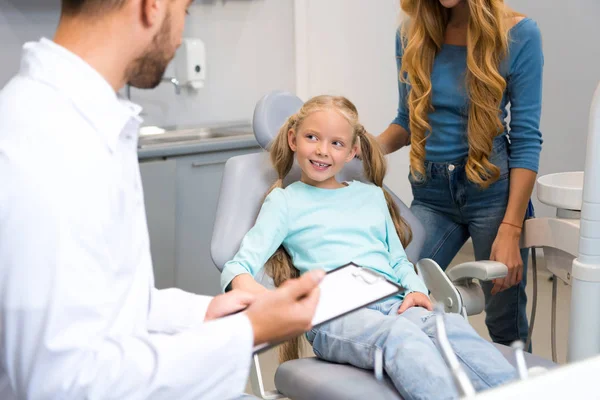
[399, 0, 520, 188]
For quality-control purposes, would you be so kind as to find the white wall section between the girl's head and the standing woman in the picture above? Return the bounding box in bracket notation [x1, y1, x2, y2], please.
[295, 0, 412, 203]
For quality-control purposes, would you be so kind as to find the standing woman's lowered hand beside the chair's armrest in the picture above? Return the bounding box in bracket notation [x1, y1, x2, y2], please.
[490, 224, 523, 295]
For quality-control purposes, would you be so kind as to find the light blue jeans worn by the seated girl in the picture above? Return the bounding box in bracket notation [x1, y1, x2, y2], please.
[307, 297, 516, 400]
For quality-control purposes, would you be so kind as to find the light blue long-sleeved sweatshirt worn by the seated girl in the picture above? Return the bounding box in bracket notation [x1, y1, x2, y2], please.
[221, 181, 428, 295]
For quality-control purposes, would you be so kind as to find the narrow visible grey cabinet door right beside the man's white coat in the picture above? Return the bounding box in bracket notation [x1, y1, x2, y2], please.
[140, 159, 177, 289]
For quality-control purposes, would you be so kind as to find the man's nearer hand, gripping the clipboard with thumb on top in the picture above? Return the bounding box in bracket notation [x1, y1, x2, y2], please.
[246, 270, 325, 345]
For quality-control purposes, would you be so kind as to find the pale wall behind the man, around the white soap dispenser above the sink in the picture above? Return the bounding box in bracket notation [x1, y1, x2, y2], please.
[0, 0, 295, 125]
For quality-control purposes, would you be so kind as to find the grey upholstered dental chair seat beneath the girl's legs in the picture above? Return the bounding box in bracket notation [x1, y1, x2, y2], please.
[275, 344, 557, 400]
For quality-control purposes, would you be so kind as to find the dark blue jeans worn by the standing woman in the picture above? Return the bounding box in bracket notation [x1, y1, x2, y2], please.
[409, 137, 529, 345]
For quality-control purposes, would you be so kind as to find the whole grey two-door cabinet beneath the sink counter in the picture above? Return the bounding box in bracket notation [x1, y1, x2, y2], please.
[140, 147, 261, 296]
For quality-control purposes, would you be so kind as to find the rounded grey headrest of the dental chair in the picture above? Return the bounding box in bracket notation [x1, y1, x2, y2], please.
[252, 90, 304, 150]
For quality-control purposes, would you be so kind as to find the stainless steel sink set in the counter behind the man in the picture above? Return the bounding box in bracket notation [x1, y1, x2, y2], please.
[138, 124, 253, 148]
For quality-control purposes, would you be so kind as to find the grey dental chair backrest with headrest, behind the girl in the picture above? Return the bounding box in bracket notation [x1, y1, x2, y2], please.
[211, 92, 425, 276]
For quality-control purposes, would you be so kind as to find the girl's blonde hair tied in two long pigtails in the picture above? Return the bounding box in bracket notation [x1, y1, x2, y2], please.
[265, 96, 412, 362]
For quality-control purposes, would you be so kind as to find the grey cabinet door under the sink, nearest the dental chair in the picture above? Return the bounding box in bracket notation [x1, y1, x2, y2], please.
[175, 149, 259, 296]
